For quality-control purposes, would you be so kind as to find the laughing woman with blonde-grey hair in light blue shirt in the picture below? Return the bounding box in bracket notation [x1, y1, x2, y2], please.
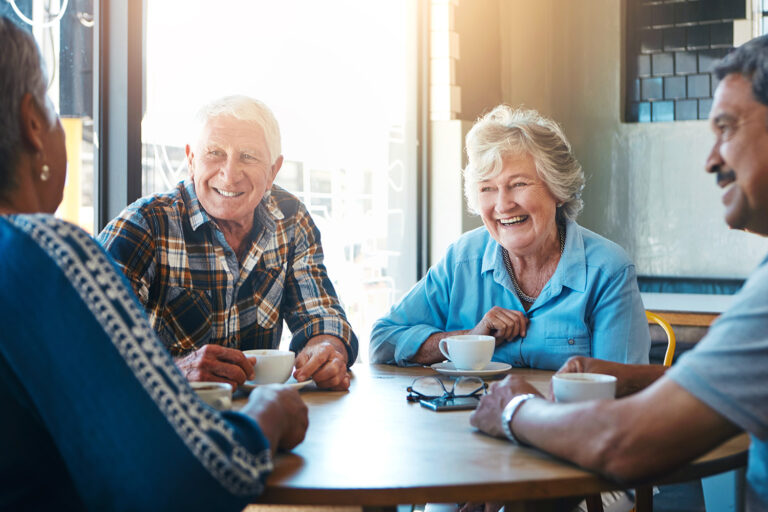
[371, 105, 650, 370]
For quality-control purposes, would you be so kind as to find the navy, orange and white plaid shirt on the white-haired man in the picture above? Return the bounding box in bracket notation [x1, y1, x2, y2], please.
[98, 180, 358, 365]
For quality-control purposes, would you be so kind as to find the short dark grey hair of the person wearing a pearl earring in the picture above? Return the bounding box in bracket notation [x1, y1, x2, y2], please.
[0, 16, 56, 198]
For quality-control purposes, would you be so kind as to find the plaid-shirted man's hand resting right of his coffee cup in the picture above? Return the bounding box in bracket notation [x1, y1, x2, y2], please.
[293, 335, 349, 391]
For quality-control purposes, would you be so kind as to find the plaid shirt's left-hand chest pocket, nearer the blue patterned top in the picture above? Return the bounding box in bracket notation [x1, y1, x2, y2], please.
[163, 286, 213, 354]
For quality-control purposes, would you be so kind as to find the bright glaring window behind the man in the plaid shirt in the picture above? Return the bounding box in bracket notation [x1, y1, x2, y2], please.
[142, 0, 417, 361]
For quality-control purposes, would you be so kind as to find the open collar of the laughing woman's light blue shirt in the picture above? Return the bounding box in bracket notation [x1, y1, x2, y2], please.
[482, 220, 587, 295]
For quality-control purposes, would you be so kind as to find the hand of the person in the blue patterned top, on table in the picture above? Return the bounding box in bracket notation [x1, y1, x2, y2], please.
[240, 384, 309, 453]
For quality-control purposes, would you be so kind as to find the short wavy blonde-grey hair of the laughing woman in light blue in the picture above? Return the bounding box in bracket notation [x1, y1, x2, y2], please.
[464, 105, 584, 223]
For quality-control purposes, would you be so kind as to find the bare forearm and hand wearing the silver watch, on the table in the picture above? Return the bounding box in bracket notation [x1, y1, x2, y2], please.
[470, 376, 739, 481]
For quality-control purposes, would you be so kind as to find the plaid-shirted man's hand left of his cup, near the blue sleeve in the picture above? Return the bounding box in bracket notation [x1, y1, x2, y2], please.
[176, 345, 254, 389]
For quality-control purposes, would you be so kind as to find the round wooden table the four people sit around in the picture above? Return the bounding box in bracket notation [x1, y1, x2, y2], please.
[235, 365, 748, 506]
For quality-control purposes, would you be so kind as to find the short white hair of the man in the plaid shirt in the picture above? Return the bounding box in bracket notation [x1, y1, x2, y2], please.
[194, 95, 282, 164]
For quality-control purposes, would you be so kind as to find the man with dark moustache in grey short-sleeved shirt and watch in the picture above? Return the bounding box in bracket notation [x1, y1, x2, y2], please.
[470, 36, 768, 510]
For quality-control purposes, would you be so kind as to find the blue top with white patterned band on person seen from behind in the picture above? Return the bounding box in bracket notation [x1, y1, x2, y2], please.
[0, 215, 272, 510]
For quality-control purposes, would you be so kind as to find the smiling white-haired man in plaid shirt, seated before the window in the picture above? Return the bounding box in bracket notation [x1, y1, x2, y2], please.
[98, 96, 358, 389]
